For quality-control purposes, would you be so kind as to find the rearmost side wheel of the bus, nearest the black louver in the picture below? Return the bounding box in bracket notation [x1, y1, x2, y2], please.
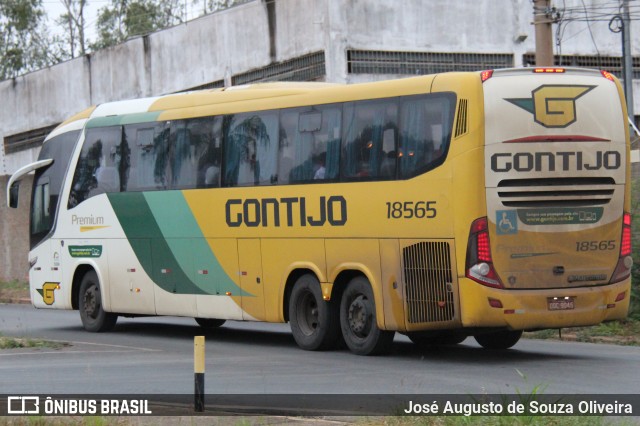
[340, 276, 395, 355]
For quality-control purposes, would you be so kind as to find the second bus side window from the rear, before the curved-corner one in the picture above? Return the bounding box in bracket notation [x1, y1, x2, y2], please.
[342, 98, 398, 180]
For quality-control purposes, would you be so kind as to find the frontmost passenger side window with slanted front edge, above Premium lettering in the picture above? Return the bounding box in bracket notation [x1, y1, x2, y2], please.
[69, 126, 125, 208]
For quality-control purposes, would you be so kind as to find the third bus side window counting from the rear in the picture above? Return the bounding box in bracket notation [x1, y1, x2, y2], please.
[278, 105, 342, 184]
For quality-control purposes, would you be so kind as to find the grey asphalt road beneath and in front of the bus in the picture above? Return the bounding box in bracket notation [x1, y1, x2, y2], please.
[0, 305, 640, 394]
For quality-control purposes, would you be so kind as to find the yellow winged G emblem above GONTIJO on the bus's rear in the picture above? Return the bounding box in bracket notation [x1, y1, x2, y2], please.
[505, 84, 596, 128]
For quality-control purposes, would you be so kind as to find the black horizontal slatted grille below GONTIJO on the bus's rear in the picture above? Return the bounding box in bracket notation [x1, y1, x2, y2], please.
[498, 178, 615, 207]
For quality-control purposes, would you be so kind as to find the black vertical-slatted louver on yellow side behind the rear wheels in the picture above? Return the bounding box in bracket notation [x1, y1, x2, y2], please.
[402, 242, 455, 323]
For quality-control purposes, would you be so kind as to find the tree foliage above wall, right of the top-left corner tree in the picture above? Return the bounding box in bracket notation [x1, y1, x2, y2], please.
[91, 0, 182, 50]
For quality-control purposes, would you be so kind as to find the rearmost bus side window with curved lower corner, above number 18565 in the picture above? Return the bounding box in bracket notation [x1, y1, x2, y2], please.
[398, 93, 456, 178]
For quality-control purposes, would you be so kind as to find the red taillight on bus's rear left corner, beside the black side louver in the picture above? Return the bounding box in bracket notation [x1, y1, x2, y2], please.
[466, 217, 503, 288]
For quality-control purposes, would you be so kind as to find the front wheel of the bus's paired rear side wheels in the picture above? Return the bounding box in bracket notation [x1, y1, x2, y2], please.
[289, 274, 340, 351]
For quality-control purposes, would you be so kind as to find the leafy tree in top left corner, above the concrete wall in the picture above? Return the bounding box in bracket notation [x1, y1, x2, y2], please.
[0, 0, 61, 80]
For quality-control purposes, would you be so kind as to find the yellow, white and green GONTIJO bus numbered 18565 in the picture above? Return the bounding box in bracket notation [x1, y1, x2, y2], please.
[8, 68, 632, 355]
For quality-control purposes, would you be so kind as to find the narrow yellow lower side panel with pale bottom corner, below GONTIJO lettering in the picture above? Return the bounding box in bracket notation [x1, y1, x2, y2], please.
[238, 238, 266, 321]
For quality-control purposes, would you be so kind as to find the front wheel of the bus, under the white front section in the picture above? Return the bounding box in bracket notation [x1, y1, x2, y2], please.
[78, 271, 118, 332]
